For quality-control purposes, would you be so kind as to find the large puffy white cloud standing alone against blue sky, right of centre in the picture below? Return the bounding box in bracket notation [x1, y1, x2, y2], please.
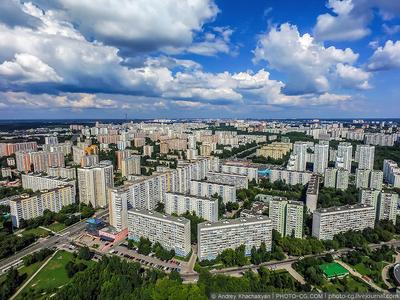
[254, 23, 362, 94]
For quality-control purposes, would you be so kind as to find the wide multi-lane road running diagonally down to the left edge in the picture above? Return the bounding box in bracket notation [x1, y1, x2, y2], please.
[0, 210, 108, 273]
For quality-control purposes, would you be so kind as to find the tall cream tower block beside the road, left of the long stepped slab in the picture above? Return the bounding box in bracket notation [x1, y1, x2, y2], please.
[78, 161, 114, 207]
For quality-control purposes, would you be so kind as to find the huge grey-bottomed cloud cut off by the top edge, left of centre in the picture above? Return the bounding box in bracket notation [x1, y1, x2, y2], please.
[41, 0, 219, 52]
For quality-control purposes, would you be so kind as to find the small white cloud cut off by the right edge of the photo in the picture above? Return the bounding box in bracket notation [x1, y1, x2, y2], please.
[368, 40, 400, 71]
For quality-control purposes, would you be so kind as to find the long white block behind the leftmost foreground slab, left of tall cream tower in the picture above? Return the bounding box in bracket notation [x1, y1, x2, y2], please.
[21, 173, 76, 199]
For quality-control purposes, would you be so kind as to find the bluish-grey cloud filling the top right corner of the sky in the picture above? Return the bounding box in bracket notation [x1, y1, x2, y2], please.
[313, 0, 400, 41]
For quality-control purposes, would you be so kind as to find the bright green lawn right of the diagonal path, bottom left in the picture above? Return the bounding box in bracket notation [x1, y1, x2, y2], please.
[18, 251, 73, 299]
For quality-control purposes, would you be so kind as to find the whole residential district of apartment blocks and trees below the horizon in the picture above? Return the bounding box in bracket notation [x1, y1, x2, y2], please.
[0, 120, 400, 299]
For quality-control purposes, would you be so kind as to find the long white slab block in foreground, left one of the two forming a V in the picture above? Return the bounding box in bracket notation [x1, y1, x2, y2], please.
[128, 208, 191, 257]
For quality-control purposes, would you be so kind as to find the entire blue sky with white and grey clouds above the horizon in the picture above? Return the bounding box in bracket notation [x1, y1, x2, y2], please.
[0, 0, 400, 119]
